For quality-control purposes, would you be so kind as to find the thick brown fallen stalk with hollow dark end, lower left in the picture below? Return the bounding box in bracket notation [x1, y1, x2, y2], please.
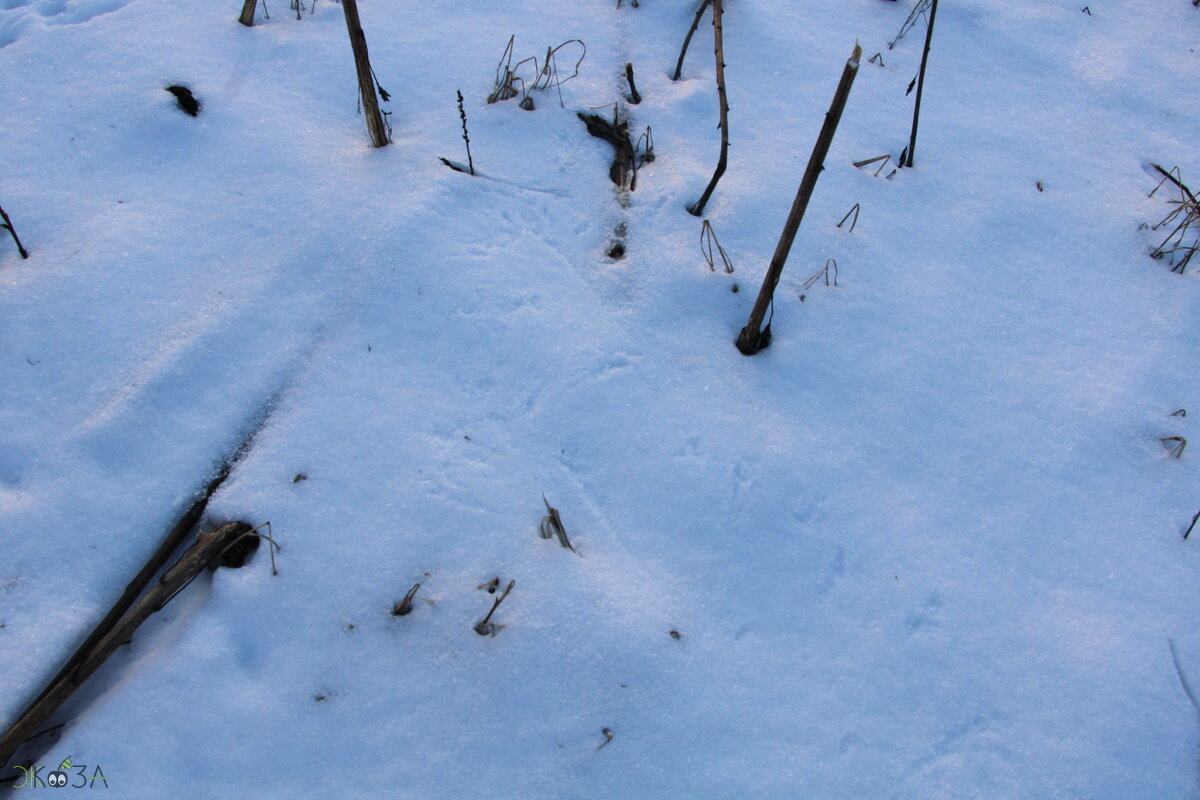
[0, 522, 250, 764]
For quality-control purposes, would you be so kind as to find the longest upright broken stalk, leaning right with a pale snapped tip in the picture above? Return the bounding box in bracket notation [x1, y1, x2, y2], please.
[737, 43, 863, 355]
